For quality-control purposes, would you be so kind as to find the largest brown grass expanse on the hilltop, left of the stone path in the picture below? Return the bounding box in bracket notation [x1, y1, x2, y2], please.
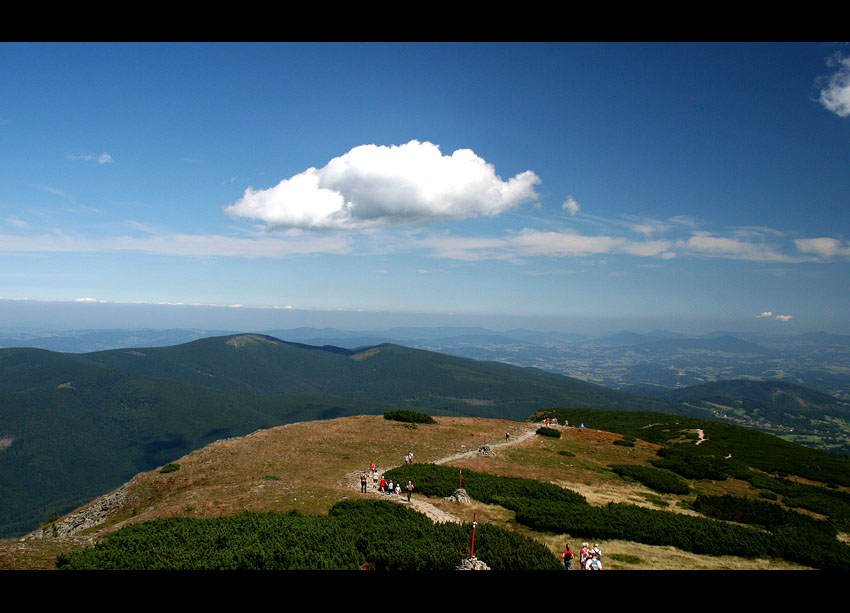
[97, 415, 522, 522]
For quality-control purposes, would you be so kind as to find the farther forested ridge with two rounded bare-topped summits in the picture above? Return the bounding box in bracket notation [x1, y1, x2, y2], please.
[81, 334, 676, 419]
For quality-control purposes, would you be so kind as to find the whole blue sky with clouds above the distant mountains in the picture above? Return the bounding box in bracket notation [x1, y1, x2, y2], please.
[0, 43, 850, 333]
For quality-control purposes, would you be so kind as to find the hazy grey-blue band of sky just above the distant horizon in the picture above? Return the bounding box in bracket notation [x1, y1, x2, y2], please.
[0, 298, 850, 336]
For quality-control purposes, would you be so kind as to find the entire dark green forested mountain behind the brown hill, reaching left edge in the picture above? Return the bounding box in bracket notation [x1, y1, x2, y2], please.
[0, 335, 675, 536]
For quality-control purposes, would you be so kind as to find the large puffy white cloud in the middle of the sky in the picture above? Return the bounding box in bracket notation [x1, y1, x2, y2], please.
[224, 140, 540, 230]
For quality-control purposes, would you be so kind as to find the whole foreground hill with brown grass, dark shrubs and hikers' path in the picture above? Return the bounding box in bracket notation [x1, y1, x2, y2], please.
[9, 409, 850, 570]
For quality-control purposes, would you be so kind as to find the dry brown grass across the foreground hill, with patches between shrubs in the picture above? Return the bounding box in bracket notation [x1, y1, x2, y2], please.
[0, 416, 816, 569]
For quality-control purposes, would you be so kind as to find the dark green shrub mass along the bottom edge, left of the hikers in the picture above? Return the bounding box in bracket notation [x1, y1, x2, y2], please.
[57, 500, 561, 570]
